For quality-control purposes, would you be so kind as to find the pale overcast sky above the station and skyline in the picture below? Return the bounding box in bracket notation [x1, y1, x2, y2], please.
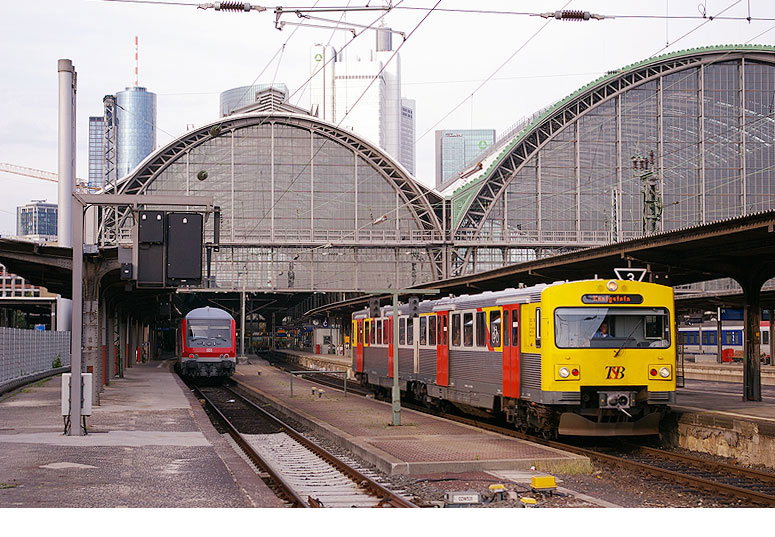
[0, 0, 775, 235]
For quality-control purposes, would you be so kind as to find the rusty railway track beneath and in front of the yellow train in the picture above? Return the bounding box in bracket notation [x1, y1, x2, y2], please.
[258, 356, 775, 507]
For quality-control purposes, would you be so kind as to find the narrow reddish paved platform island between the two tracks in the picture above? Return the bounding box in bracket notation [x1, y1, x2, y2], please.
[234, 357, 591, 474]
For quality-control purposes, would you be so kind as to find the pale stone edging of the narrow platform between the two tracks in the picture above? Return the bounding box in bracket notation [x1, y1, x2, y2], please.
[232, 378, 592, 475]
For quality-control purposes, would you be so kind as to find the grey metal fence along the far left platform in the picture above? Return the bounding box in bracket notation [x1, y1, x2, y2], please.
[0, 328, 70, 391]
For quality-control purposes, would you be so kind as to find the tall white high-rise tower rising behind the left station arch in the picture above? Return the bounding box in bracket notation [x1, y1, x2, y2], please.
[310, 28, 414, 174]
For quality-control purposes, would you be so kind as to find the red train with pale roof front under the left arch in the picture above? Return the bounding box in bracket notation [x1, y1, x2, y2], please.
[176, 306, 237, 379]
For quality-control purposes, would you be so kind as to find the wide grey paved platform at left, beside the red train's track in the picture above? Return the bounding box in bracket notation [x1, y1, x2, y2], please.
[0, 361, 282, 508]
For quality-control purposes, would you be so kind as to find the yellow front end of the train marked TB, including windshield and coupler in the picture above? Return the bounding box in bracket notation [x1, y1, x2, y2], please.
[536, 280, 676, 436]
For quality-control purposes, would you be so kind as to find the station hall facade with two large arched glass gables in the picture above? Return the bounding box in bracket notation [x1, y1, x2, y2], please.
[103, 45, 775, 298]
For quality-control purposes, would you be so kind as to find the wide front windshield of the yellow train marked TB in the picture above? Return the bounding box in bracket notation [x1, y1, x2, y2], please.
[554, 307, 670, 349]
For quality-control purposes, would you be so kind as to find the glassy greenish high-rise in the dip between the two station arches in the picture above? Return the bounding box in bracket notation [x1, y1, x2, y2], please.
[436, 129, 495, 187]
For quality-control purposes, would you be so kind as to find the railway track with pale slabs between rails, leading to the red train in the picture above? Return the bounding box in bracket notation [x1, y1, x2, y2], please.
[194, 387, 417, 507]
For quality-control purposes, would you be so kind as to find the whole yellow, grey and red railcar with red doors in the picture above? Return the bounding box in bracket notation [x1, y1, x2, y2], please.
[353, 280, 676, 436]
